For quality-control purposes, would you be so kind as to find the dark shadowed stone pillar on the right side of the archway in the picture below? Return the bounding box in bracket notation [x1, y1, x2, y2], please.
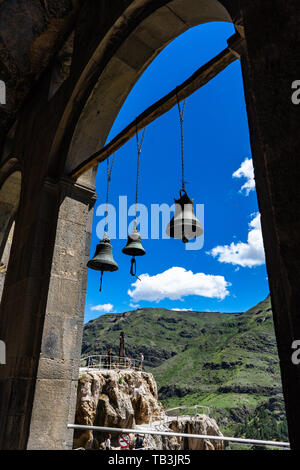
[241, 0, 300, 449]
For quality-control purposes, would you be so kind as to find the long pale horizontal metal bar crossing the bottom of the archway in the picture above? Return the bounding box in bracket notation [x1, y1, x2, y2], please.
[68, 424, 290, 448]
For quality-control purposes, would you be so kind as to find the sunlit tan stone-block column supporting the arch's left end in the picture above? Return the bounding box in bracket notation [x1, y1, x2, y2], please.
[0, 175, 94, 449]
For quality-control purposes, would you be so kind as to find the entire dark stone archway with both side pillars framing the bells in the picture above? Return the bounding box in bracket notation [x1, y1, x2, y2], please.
[0, 0, 300, 449]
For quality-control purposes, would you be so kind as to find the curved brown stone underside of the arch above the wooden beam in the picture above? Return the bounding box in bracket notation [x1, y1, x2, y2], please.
[66, 0, 232, 173]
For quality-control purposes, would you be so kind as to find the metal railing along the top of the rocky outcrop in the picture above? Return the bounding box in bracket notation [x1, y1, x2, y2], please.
[80, 354, 143, 370]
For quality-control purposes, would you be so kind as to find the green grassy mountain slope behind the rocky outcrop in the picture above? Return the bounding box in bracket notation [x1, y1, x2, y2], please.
[82, 297, 287, 440]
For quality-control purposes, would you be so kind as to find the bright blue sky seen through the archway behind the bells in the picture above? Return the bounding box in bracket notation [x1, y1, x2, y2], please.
[85, 23, 269, 321]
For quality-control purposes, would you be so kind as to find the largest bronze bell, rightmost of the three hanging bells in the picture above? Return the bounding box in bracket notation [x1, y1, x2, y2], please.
[166, 191, 203, 243]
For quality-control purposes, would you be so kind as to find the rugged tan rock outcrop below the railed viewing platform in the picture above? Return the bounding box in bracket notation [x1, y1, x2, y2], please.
[74, 370, 223, 450]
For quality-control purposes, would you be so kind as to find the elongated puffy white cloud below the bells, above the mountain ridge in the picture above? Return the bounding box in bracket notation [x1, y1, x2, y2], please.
[128, 266, 231, 302]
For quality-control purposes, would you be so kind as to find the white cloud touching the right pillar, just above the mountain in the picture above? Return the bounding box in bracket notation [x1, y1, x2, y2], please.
[208, 214, 265, 268]
